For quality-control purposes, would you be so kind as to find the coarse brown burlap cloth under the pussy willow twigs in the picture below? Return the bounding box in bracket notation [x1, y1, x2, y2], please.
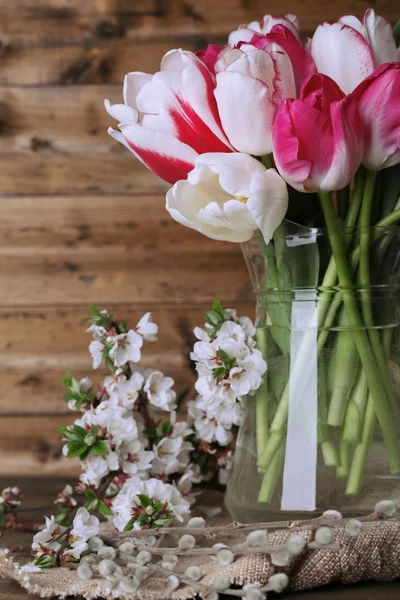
[0, 518, 400, 600]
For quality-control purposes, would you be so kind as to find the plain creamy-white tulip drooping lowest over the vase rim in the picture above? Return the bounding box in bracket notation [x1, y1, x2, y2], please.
[166, 153, 288, 243]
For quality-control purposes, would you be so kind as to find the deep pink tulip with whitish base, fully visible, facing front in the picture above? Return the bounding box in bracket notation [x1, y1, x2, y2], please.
[273, 75, 364, 192]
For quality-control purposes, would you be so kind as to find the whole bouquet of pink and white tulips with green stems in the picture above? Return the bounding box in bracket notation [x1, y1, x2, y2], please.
[106, 9, 400, 502]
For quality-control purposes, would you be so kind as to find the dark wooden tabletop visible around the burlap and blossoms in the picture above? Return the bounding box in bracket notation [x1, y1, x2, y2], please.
[0, 477, 400, 600]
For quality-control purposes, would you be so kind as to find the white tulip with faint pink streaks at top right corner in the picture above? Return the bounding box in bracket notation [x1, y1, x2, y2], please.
[311, 8, 398, 94]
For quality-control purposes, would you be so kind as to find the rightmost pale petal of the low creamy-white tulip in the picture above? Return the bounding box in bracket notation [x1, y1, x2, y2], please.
[247, 169, 289, 244]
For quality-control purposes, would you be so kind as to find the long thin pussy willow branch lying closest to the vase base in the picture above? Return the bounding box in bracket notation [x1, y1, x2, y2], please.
[101, 513, 400, 540]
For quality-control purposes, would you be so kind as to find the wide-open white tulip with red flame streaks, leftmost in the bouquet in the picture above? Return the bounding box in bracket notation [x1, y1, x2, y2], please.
[105, 50, 233, 183]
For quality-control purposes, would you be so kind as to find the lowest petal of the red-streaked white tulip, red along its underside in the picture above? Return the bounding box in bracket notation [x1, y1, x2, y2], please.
[108, 124, 197, 183]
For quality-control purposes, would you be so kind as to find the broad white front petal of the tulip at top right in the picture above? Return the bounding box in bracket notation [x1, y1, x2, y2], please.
[311, 23, 374, 94]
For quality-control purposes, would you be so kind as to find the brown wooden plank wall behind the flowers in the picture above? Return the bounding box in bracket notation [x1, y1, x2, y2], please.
[0, 0, 399, 475]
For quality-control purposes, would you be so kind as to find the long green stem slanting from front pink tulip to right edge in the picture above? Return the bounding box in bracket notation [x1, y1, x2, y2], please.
[320, 192, 400, 473]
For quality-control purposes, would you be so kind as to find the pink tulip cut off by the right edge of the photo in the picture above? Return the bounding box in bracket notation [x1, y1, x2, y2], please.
[352, 62, 400, 171]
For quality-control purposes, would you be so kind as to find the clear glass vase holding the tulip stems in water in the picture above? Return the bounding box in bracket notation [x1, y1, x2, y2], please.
[226, 222, 400, 522]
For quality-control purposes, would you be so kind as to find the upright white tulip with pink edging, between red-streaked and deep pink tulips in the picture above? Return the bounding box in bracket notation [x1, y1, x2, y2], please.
[214, 44, 296, 156]
